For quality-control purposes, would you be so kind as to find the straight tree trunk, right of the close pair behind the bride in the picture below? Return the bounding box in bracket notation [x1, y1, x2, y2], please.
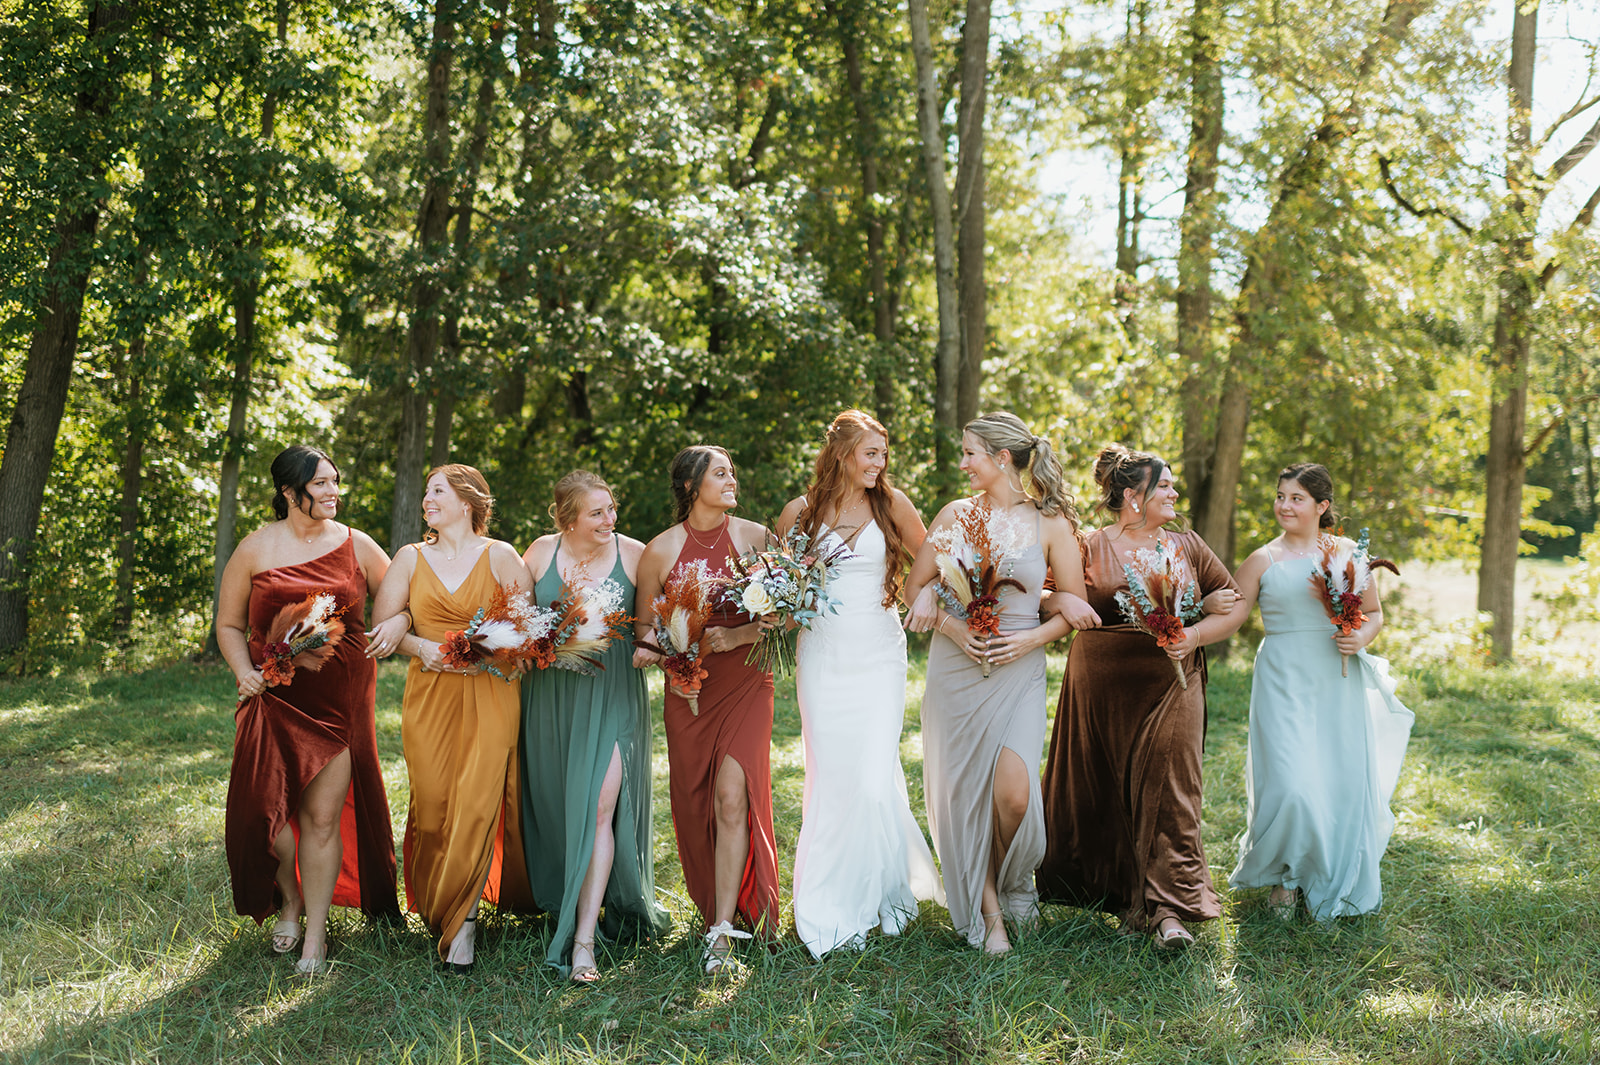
[955, 0, 989, 427]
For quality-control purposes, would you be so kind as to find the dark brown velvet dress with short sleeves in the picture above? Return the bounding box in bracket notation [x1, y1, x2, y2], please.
[1037, 529, 1235, 929]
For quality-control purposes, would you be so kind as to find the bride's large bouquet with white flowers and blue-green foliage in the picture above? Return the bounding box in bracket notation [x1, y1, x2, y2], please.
[722, 526, 850, 676]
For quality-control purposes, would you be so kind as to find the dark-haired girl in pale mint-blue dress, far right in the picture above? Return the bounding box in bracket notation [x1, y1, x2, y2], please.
[1227, 462, 1413, 921]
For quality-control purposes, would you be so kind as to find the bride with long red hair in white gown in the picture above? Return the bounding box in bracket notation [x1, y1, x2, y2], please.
[778, 411, 944, 958]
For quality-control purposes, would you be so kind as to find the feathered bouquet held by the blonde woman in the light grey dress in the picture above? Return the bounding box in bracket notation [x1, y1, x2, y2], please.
[928, 499, 1027, 676]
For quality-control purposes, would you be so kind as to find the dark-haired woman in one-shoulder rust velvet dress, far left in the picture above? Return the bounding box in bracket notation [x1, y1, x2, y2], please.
[216, 445, 405, 975]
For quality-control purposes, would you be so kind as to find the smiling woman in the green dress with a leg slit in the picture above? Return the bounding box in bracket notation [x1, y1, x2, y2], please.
[522, 470, 672, 983]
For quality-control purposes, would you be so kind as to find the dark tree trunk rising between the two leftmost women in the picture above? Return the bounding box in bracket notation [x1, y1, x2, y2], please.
[389, 0, 456, 555]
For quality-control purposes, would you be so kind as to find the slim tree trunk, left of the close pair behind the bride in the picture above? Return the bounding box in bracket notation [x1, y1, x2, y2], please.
[907, 0, 962, 466]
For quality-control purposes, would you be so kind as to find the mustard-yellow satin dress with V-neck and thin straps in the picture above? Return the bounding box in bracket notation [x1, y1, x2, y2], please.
[400, 547, 533, 958]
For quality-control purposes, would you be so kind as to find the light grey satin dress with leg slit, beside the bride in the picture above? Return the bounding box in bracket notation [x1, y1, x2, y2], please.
[922, 505, 1048, 947]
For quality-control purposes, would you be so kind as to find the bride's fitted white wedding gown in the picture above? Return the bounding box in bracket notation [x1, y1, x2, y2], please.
[794, 523, 944, 958]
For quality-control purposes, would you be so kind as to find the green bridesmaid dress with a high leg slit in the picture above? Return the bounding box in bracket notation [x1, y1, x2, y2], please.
[520, 542, 672, 974]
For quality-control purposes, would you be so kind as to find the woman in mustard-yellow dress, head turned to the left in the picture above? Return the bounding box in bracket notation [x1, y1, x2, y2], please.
[373, 462, 531, 975]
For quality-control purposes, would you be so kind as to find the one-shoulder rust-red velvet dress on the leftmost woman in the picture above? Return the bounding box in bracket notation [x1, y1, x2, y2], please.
[224, 536, 400, 923]
